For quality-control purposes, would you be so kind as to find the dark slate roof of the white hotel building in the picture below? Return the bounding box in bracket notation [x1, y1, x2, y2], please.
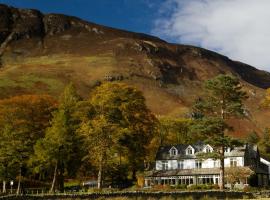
[156, 142, 258, 160]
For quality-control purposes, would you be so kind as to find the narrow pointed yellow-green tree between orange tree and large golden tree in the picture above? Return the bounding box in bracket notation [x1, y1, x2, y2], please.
[33, 84, 80, 192]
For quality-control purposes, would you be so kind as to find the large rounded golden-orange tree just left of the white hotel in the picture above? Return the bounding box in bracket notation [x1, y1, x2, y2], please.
[80, 82, 157, 187]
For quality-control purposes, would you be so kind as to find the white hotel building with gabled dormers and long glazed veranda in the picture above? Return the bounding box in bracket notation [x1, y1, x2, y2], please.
[145, 142, 270, 187]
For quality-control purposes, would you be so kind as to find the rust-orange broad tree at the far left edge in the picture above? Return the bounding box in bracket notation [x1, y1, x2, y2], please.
[0, 95, 56, 193]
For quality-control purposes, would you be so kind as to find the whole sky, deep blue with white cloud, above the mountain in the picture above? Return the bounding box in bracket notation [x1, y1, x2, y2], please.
[0, 0, 270, 71]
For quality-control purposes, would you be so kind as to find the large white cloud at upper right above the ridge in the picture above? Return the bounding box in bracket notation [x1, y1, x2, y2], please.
[152, 0, 270, 71]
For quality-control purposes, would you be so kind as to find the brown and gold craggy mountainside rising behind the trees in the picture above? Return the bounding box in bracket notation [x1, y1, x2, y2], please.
[0, 4, 270, 136]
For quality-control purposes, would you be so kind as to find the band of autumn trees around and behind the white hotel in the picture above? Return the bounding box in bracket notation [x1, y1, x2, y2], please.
[0, 75, 270, 193]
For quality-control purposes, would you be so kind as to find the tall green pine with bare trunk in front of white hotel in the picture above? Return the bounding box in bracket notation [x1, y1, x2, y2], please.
[194, 75, 247, 189]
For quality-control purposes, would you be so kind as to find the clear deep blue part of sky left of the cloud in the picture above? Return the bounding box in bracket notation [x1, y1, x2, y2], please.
[0, 0, 163, 33]
